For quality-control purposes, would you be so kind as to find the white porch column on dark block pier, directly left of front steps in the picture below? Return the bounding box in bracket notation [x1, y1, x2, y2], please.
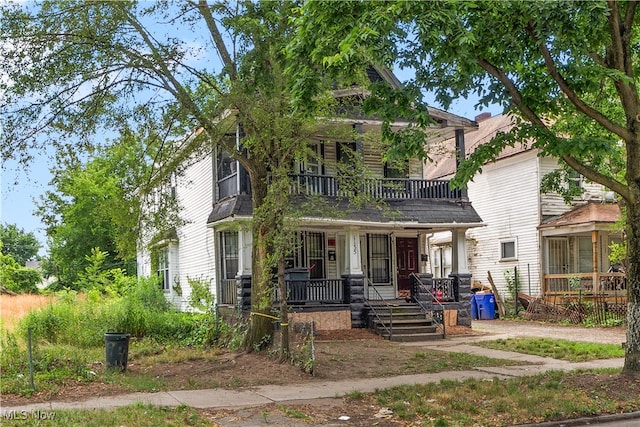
[342, 227, 366, 328]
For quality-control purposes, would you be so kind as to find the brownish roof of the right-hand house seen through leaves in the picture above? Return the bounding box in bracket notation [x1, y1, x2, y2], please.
[425, 113, 531, 179]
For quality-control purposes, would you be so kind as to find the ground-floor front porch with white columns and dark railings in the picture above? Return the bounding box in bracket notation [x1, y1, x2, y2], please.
[216, 220, 479, 328]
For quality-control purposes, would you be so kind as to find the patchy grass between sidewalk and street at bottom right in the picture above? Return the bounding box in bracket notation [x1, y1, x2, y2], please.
[362, 371, 640, 426]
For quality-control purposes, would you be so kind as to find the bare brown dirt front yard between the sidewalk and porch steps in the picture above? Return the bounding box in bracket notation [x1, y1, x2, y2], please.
[2, 327, 474, 406]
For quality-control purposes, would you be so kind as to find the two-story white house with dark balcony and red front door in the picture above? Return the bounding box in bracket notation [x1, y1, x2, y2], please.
[139, 68, 482, 329]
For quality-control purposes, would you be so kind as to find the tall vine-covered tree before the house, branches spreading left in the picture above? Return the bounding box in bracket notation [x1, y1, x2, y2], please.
[0, 0, 332, 348]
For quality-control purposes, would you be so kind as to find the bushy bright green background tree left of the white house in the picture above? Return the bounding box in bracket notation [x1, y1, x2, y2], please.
[36, 131, 151, 288]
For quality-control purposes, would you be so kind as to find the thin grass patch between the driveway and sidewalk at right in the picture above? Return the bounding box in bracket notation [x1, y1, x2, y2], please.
[473, 338, 624, 362]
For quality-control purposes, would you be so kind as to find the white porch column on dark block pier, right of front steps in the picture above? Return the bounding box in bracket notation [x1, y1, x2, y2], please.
[449, 228, 471, 326]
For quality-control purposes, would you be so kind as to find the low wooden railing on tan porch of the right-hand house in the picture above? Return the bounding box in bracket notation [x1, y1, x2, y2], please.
[543, 273, 627, 295]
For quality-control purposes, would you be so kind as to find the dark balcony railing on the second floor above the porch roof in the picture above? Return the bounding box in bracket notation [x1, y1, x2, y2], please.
[290, 174, 463, 200]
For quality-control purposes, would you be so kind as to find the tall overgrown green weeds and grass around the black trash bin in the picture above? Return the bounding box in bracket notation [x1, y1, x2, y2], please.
[0, 279, 240, 396]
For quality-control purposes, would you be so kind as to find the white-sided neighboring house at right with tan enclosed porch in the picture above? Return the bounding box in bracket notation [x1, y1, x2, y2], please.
[425, 113, 624, 306]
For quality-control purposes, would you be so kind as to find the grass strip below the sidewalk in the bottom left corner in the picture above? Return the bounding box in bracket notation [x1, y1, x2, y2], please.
[2, 404, 215, 427]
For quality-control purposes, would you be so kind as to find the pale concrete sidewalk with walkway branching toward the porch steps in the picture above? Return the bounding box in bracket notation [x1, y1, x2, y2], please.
[2, 337, 624, 411]
